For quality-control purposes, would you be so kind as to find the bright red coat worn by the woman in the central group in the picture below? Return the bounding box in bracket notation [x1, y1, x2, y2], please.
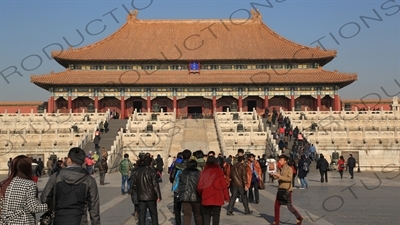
[197, 164, 229, 206]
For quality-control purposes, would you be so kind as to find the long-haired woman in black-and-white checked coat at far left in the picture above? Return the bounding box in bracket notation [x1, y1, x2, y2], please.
[0, 155, 48, 225]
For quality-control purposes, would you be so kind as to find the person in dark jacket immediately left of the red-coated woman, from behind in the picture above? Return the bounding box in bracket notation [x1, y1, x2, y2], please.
[178, 160, 203, 225]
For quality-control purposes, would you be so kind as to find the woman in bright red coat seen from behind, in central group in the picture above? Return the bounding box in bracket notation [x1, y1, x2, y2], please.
[197, 156, 229, 225]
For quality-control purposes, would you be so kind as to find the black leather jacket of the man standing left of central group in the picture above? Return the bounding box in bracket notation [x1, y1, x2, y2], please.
[132, 166, 161, 202]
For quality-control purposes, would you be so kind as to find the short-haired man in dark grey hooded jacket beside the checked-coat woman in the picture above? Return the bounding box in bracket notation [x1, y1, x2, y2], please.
[40, 147, 100, 225]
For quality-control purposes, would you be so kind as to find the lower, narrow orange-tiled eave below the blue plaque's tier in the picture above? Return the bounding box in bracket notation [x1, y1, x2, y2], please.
[31, 68, 357, 89]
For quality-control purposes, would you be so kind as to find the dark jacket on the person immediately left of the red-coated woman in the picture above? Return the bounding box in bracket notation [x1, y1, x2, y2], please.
[178, 169, 201, 202]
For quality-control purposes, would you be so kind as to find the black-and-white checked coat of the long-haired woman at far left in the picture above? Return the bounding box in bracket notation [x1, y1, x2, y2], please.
[0, 177, 47, 225]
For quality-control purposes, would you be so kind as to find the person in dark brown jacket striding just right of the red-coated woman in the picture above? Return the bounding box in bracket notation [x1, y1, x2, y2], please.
[226, 156, 252, 216]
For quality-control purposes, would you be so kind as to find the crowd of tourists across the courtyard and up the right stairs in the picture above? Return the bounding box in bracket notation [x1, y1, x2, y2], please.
[0, 108, 356, 225]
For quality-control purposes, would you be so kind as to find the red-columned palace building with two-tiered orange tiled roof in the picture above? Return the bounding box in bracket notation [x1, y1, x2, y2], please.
[31, 10, 357, 118]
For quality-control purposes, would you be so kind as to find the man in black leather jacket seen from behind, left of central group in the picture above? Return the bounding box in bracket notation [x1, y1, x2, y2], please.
[132, 156, 161, 225]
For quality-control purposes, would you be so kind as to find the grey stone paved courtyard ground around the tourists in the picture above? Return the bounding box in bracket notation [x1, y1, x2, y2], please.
[1, 163, 400, 225]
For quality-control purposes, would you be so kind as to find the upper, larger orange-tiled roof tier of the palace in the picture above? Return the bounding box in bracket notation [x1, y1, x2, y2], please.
[52, 10, 336, 67]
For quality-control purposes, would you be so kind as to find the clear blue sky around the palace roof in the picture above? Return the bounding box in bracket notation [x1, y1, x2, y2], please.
[0, 0, 400, 101]
